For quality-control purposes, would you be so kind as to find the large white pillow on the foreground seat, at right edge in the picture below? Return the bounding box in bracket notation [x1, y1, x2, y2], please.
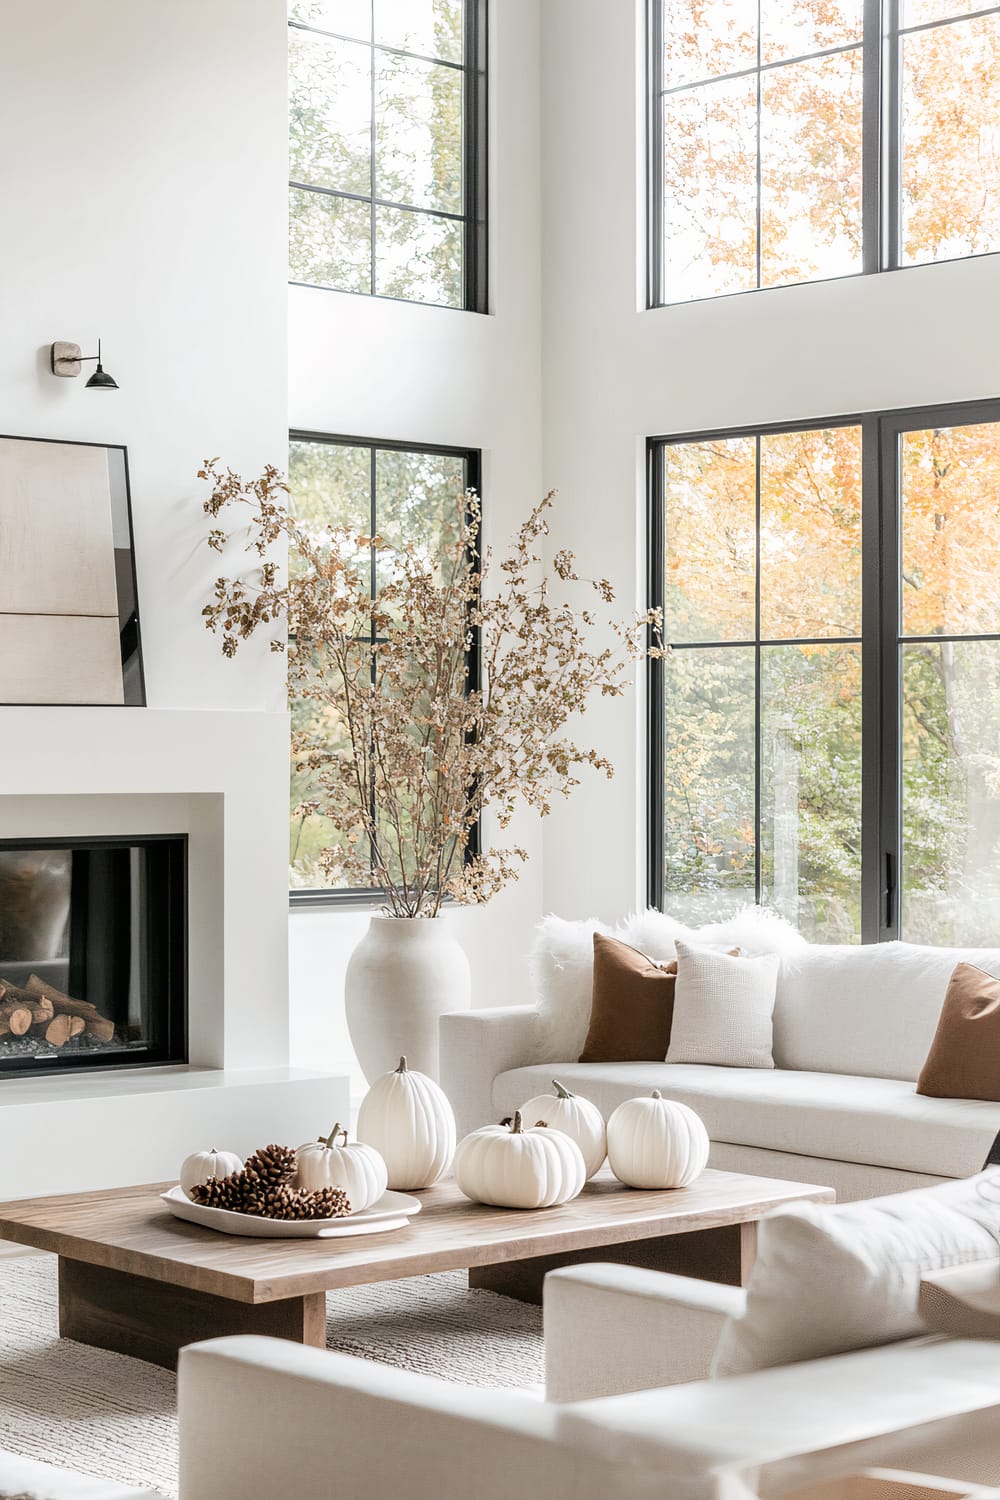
[712, 1169, 1000, 1376]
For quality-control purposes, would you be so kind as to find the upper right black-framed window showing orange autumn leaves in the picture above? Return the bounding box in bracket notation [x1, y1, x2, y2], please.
[648, 0, 1000, 308]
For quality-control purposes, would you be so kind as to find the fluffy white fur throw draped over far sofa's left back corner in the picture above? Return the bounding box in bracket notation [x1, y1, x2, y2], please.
[529, 906, 808, 1062]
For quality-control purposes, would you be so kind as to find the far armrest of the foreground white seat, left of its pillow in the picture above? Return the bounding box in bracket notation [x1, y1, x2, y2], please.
[544, 1265, 747, 1401]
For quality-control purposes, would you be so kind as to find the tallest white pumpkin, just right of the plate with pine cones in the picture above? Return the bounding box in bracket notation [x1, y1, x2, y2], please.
[357, 1058, 456, 1193]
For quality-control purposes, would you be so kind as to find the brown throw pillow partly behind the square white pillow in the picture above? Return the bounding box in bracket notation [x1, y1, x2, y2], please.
[580, 933, 678, 1062]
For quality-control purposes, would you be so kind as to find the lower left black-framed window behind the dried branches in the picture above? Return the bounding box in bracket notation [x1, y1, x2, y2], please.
[288, 431, 481, 908]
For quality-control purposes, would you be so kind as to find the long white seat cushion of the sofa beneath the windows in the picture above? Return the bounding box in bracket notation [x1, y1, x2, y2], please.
[493, 1062, 1000, 1178]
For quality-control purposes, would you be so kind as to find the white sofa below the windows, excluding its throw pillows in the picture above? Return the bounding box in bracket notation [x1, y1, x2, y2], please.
[441, 914, 1000, 1200]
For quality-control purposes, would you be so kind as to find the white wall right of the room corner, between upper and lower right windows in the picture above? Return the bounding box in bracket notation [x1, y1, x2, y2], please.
[541, 0, 1000, 918]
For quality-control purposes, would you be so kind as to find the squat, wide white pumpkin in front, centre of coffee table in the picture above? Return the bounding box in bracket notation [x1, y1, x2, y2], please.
[454, 1110, 586, 1209]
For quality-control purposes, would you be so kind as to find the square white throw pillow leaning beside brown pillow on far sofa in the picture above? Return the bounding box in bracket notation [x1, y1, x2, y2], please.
[666, 939, 781, 1068]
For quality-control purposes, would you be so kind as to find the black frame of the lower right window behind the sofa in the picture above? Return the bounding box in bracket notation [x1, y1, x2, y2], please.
[646, 396, 1000, 944]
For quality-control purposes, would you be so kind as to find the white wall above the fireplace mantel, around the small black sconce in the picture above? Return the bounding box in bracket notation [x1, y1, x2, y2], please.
[0, 0, 286, 714]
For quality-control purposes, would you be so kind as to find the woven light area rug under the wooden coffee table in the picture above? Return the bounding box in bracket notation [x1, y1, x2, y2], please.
[0, 1256, 544, 1496]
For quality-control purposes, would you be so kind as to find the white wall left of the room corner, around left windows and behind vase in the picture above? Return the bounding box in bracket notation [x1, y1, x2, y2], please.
[289, 0, 541, 1086]
